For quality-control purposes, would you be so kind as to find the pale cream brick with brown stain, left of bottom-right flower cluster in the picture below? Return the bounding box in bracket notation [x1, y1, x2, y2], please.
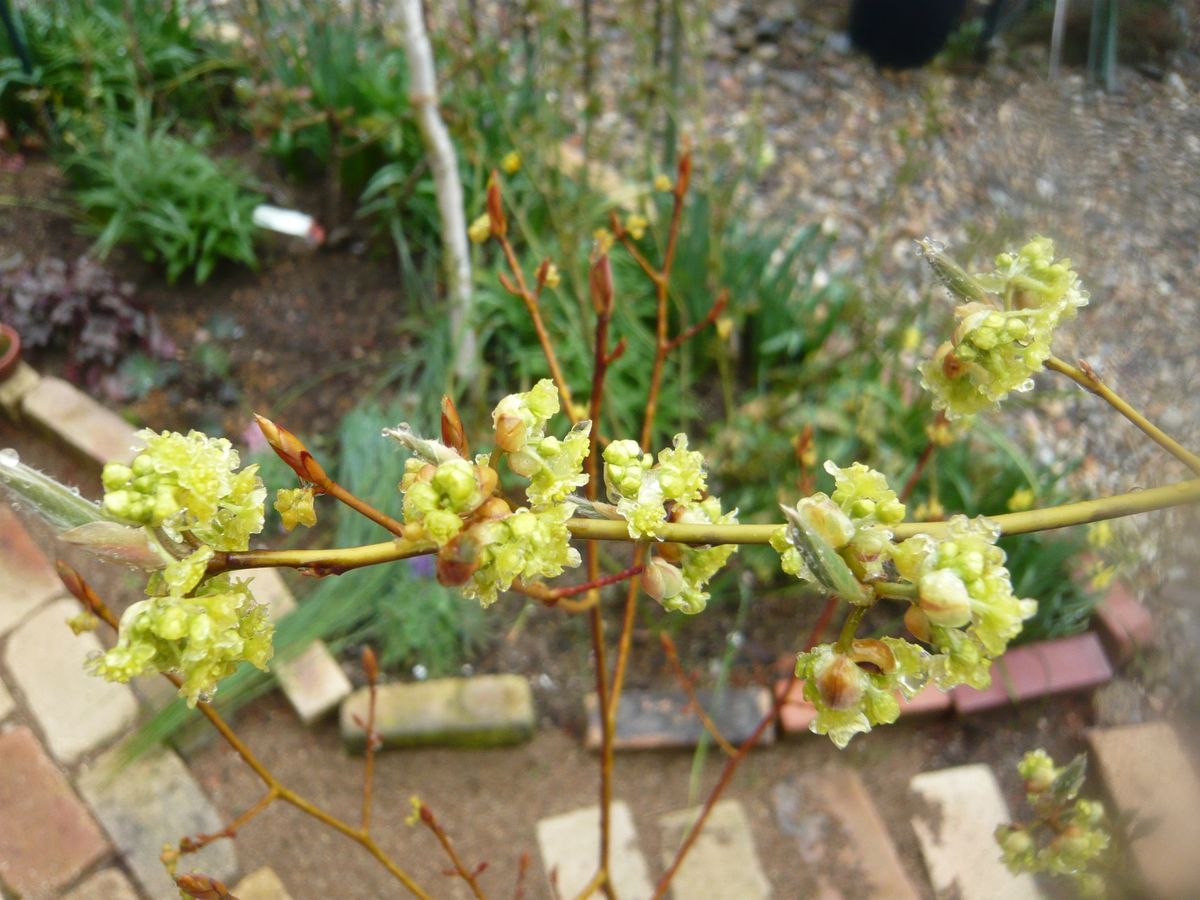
[908, 763, 1040, 900]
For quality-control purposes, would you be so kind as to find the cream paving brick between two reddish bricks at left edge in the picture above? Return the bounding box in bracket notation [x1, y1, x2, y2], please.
[5, 600, 138, 763]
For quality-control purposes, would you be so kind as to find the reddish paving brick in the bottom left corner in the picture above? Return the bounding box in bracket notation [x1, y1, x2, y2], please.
[0, 727, 108, 900]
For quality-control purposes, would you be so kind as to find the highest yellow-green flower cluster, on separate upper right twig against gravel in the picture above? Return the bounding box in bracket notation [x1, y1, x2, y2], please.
[920, 236, 1088, 416]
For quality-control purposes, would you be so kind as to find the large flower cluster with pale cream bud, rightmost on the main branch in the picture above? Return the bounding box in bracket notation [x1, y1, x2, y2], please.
[892, 516, 1038, 690]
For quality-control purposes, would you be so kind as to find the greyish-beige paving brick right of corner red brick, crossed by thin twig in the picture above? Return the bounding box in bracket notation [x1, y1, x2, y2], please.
[78, 748, 238, 898]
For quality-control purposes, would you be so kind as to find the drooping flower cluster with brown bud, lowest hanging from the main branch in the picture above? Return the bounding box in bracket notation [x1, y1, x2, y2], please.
[796, 637, 929, 748]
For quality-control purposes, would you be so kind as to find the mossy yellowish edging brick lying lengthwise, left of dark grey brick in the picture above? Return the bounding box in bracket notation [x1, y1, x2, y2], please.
[341, 674, 534, 750]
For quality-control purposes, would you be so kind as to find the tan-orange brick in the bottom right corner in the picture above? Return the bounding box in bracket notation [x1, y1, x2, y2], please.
[1087, 722, 1200, 899]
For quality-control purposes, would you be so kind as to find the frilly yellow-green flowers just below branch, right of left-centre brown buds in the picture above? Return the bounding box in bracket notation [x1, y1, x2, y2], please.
[461, 503, 581, 606]
